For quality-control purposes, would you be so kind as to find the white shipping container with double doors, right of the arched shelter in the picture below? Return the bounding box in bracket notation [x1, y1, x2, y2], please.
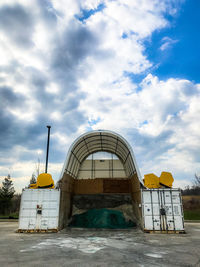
[141, 188, 184, 232]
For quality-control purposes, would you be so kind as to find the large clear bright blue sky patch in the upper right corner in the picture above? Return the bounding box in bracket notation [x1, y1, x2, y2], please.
[145, 0, 200, 82]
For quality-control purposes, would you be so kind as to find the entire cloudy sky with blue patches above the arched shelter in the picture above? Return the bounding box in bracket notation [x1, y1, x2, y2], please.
[0, 0, 200, 191]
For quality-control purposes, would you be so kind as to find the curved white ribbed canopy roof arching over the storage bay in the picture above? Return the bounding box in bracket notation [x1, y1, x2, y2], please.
[61, 130, 141, 181]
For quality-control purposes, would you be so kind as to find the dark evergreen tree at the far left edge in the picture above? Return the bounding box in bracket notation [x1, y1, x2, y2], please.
[0, 174, 15, 214]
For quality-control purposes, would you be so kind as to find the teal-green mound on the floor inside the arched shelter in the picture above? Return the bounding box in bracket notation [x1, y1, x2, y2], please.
[69, 209, 136, 229]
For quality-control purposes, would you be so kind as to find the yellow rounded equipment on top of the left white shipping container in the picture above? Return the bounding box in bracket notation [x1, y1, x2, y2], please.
[29, 173, 55, 189]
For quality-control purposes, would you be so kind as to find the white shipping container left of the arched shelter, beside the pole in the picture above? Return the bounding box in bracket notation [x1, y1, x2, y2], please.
[19, 189, 60, 231]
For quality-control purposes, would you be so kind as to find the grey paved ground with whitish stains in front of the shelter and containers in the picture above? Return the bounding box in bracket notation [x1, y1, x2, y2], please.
[0, 222, 200, 267]
